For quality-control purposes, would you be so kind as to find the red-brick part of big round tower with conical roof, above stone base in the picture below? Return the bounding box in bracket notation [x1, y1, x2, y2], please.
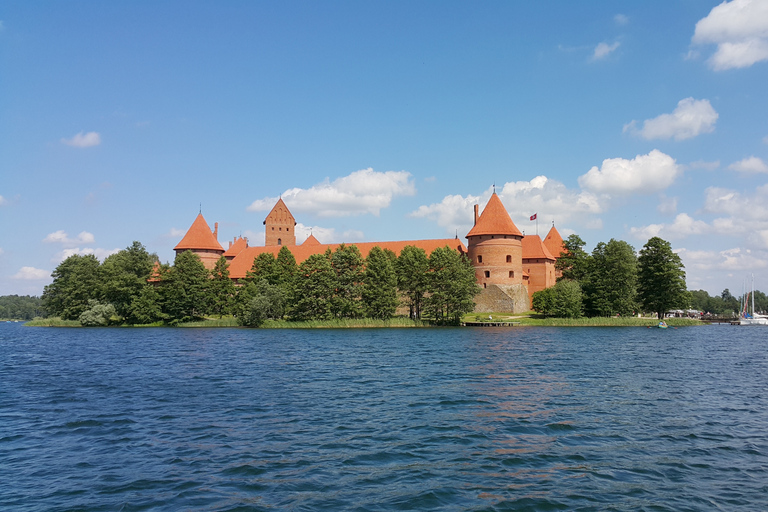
[467, 192, 523, 288]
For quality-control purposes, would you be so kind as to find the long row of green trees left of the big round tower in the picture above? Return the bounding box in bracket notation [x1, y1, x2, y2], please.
[42, 242, 479, 326]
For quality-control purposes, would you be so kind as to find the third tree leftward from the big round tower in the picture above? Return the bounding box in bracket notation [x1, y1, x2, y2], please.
[362, 246, 398, 319]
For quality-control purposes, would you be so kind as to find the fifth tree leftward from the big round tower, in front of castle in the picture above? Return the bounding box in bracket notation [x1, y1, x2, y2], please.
[290, 254, 336, 320]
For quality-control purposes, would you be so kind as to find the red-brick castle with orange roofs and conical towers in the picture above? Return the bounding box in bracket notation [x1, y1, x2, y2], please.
[173, 192, 563, 313]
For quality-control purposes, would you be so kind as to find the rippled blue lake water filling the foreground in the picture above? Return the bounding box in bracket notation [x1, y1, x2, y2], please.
[0, 324, 768, 511]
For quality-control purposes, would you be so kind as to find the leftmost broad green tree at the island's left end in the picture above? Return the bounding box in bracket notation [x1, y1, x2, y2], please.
[43, 254, 102, 320]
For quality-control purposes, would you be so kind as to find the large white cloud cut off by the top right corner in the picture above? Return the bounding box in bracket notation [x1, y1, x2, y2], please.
[692, 0, 768, 71]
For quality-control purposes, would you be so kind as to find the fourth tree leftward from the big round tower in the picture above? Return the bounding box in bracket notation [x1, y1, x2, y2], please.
[329, 244, 364, 318]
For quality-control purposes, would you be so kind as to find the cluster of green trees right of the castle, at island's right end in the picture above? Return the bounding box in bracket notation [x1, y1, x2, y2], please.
[532, 235, 691, 318]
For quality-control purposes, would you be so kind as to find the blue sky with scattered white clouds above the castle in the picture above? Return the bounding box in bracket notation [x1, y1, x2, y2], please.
[0, 0, 768, 295]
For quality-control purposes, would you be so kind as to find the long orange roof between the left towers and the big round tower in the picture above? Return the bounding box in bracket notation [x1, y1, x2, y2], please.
[229, 237, 467, 279]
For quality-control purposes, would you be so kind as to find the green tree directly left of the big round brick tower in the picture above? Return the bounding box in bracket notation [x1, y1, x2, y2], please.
[425, 246, 480, 325]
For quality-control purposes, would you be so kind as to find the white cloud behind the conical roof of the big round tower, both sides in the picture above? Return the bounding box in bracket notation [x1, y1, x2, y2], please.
[410, 176, 603, 234]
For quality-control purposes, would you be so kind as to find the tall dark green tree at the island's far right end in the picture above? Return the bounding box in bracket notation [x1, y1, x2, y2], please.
[638, 236, 690, 319]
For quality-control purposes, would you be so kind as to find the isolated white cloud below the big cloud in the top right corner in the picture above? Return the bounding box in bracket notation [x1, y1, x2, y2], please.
[624, 98, 719, 140]
